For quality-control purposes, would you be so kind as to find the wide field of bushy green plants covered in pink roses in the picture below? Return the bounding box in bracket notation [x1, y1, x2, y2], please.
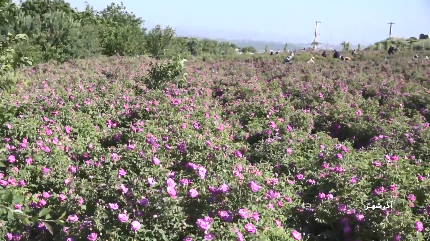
[0, 52, 430, 241]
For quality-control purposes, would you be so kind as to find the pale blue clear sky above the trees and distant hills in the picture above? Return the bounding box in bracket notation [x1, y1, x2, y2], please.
[15, 0, 430, 44]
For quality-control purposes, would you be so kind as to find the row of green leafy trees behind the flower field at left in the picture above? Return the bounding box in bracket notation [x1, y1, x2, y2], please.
[0, 0, 256, 63]
